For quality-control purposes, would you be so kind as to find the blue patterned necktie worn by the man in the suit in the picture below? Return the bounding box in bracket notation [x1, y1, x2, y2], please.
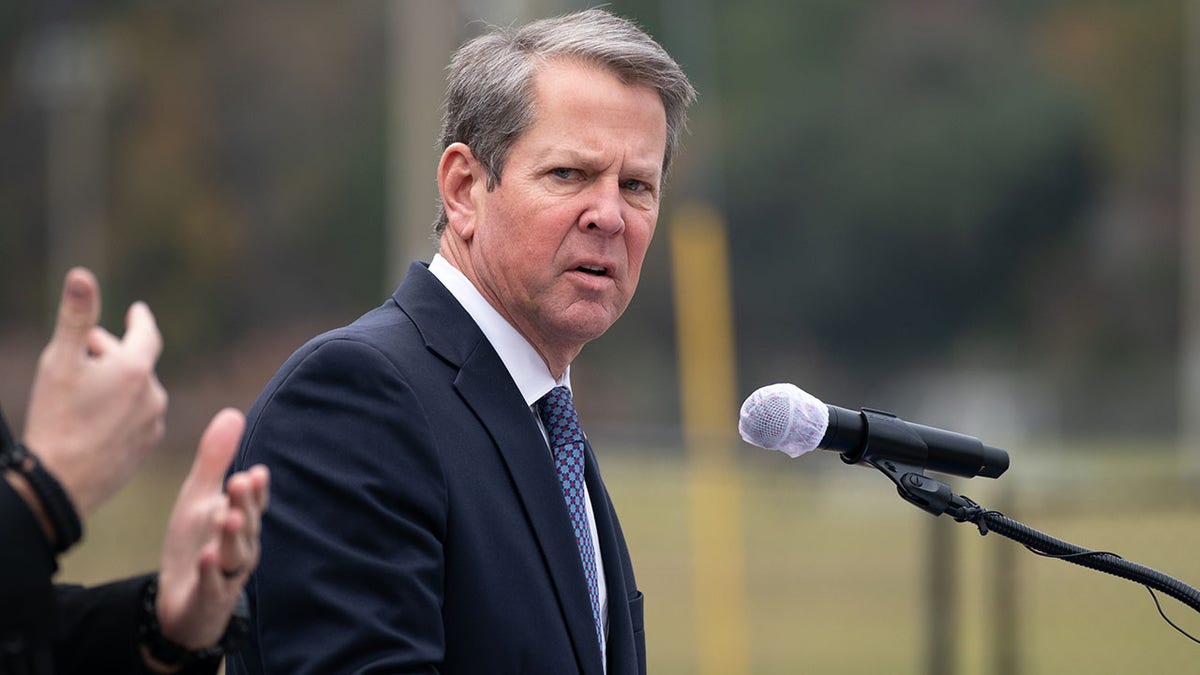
[538, 387, 604, 644]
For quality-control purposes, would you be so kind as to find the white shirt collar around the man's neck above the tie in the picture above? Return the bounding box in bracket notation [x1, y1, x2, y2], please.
[430, 253, 571, 406]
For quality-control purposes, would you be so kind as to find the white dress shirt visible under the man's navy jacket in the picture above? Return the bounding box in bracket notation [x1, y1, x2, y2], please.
[430, 253, 608, 671]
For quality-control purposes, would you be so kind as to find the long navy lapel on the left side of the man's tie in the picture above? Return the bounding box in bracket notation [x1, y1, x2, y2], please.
[395, 263, 602, 675]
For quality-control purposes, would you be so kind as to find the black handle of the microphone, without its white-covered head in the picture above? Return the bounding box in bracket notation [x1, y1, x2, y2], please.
[817, 406, 1008, 478]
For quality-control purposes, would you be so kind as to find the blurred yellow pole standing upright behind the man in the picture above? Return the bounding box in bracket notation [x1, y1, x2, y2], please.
[671, 203, 749, 675]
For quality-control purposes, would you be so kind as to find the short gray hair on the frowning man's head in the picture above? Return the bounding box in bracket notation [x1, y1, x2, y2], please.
[434, 10, 696, 237]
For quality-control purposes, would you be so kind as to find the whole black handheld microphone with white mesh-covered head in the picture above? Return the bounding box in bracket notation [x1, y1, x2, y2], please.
[738, 383, 1008, 478]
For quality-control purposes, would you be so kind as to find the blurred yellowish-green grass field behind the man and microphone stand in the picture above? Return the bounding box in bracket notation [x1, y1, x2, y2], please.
[60, 437, 1200, 675]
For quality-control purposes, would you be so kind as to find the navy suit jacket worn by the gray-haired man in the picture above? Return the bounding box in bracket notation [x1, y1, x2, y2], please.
[227, 263, 646, 675]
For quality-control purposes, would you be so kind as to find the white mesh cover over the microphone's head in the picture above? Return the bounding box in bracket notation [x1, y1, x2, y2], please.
[738, 383, 829, 458]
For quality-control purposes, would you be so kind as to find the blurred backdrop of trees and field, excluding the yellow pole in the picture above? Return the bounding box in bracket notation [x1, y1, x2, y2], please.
[0, 0, 1200, 674]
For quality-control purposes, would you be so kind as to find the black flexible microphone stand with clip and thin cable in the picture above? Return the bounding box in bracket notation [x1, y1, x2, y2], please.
[859, 454, 1200, 611]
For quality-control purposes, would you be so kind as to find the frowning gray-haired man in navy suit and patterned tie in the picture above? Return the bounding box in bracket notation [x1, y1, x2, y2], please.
[229, 10, 695, 675]
